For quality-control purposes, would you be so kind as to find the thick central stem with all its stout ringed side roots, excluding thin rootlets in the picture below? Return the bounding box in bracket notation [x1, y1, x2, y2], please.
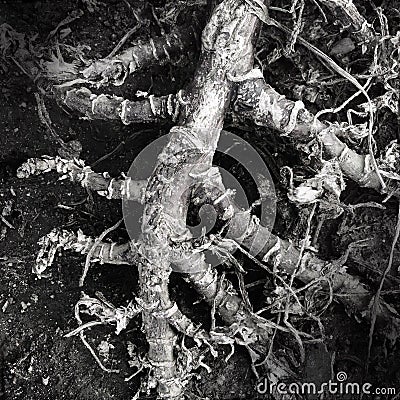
[7, 0, 398, 399]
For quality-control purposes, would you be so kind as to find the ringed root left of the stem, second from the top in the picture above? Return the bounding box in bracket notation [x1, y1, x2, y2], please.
[62, 88, 180, 125]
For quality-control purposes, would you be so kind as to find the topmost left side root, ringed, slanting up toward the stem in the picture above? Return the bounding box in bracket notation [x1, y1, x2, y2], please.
[82, 19, 201, 86]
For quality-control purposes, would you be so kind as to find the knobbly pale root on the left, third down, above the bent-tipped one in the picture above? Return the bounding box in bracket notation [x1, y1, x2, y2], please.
[17, 156, 147, 202]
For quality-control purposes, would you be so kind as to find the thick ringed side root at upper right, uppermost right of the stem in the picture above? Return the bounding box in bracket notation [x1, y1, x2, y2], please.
[234, 79, 383, 192]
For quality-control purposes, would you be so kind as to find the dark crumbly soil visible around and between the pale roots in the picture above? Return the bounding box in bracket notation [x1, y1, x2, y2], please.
[0, 0, 400, 400]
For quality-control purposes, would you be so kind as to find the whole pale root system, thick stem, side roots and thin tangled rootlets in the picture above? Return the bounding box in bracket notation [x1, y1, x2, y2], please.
[7, 0, 400, 400]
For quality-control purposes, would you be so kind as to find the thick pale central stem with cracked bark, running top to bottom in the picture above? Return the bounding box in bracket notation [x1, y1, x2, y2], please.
[139, 0, 259, 398]
